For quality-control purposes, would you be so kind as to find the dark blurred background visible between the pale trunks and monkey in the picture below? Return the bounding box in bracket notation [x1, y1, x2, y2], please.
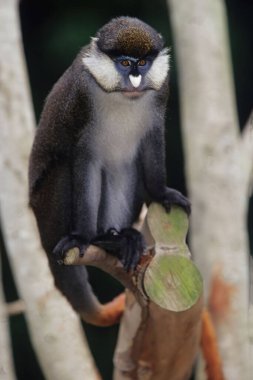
[0, 0, 253, 380]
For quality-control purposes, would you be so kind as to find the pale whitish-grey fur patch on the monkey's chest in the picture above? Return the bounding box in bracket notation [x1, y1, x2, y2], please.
[94, 94, 151, 166]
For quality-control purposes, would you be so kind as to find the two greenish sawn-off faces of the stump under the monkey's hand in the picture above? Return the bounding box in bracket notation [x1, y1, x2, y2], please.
[143, 203, 203, 312]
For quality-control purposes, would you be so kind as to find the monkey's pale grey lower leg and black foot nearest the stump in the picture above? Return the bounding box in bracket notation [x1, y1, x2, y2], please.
[91, 166, 145, 271]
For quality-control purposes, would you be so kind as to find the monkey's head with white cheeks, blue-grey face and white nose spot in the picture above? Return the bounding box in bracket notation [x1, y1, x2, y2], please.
[82, 17, 169, 97]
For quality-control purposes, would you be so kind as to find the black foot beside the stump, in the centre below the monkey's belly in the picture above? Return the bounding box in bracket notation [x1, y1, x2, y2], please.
[91, 228, 146, 272]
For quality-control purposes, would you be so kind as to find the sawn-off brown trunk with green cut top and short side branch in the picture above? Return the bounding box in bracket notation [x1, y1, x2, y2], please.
[65, 204, 202, 380]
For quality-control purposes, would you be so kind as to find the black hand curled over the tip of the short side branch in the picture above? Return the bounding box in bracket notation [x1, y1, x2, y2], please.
[53, 234, 88, 264]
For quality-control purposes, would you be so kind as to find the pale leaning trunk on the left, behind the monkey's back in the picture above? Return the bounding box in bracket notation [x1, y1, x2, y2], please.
[0, 0, 98, 380]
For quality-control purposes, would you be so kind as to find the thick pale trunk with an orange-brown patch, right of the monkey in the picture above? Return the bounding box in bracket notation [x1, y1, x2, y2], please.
[168, 0, 253, 380]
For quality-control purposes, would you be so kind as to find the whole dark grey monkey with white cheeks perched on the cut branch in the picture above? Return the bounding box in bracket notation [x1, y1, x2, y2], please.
[29, 17, 190, 322]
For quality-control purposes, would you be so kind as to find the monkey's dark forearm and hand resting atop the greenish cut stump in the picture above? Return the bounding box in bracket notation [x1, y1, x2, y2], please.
[141, 125, 191, 214]
